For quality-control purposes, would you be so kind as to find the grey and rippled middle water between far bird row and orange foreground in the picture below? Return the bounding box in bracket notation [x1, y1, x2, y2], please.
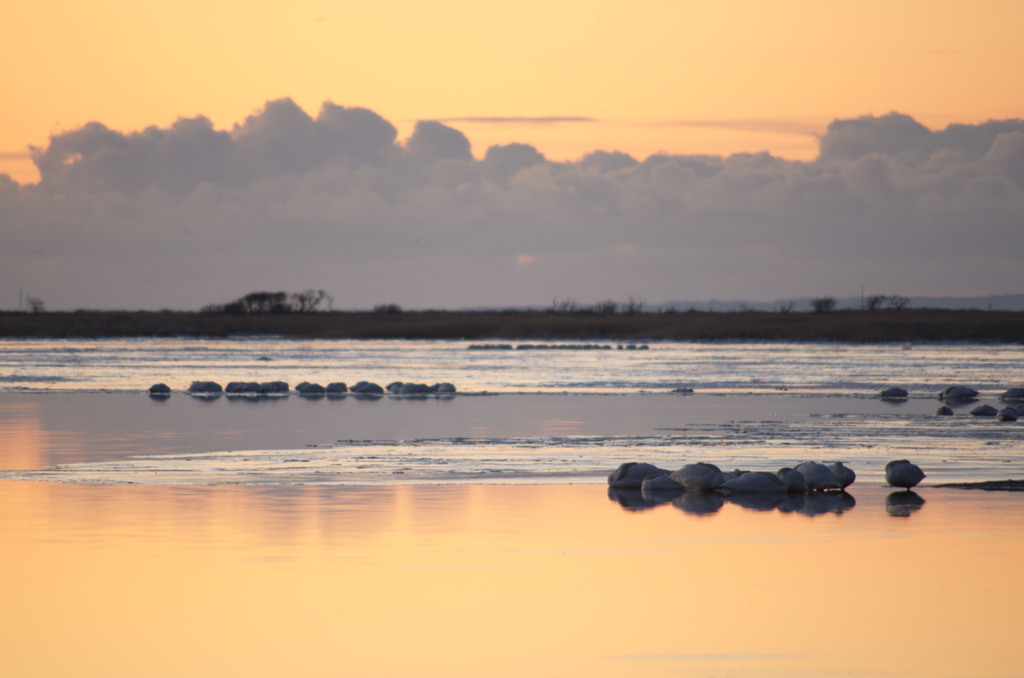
[0, 392, 1024, 485]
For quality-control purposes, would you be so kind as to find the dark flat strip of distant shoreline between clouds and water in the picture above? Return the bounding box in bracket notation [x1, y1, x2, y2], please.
[0, 308, 1024, 343]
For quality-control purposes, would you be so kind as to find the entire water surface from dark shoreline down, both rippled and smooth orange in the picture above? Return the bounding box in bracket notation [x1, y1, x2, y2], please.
[0, 339, 1024, 678]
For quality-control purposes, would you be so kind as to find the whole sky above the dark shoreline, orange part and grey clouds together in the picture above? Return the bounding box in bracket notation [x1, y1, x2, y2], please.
[0, 0, 1024, 309]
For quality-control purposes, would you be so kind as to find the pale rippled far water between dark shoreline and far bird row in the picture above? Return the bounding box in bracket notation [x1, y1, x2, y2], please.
[0, 337, 1024, 397]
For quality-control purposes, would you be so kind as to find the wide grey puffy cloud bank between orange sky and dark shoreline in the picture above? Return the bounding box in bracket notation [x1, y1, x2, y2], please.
[0, 99, 1024, 308]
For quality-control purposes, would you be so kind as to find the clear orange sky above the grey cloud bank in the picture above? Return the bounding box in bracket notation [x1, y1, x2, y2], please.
[0, 0, 1024, 182]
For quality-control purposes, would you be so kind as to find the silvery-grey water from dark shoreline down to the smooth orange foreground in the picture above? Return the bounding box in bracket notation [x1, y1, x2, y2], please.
[0, 337, 1024, 485]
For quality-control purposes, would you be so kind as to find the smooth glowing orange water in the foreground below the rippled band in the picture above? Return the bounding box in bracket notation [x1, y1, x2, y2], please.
[0, 482, 1024, 677]
